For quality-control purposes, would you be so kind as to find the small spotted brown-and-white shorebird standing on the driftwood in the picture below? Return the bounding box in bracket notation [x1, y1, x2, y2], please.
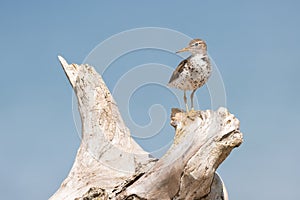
[168, 38, 212, 113]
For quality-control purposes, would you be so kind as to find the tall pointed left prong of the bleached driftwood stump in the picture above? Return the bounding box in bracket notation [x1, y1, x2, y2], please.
[50, 56, 155, 200]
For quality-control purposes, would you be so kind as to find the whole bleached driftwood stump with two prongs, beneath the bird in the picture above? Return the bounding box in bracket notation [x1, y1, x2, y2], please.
[50, 56, 242, 200]
